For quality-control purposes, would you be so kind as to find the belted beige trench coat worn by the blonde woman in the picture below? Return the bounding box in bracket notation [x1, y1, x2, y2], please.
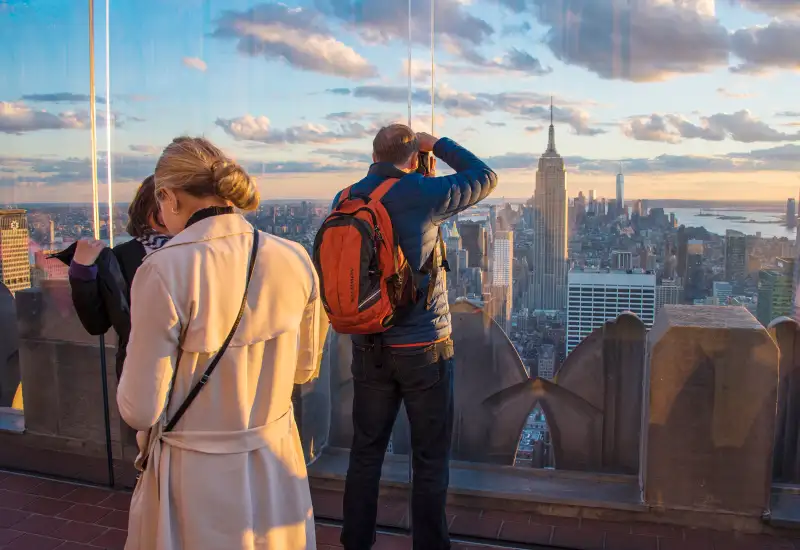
[117, 214, 327, 550]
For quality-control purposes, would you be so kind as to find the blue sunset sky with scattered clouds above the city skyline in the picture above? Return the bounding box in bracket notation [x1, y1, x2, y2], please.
[0, 0, 800, 204]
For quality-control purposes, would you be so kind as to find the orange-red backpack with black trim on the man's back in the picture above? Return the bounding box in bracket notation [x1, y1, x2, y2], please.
[314, 179, 416, 334]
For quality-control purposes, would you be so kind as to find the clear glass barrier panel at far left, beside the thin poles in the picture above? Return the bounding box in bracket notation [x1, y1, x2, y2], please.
[0, 2, 114, 483]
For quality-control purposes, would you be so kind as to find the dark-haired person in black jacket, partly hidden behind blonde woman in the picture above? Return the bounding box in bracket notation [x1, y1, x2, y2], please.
[56, 176, 169, 380]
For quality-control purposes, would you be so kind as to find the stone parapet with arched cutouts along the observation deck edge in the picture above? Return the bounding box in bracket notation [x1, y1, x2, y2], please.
[0, 281, 800, 531]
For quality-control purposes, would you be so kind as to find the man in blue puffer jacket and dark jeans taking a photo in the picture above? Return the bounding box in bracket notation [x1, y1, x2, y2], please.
[334, 124, 497, 550]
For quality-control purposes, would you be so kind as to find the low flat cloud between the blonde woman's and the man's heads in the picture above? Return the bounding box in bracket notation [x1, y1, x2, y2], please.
[215, 114, 375, 144]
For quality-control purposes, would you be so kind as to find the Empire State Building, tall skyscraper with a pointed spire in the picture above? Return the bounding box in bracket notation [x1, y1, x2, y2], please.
[533, 101, 568, 310]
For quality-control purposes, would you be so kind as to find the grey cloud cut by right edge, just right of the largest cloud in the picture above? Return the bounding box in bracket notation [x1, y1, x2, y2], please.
[731, 20, 800, 73]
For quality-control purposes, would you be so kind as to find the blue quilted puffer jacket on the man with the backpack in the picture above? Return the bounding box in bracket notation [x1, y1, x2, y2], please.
[333, 138, 497, 346]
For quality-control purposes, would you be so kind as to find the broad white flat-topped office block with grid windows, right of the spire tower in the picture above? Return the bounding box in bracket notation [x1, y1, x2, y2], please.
[567, 270, 656, 354]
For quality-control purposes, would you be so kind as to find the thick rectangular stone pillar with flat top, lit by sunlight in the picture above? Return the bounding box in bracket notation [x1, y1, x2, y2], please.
[641, 306, 778, 517]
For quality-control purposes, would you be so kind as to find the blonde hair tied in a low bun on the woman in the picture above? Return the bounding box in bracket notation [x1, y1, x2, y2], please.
[155, 136, 261, 210]
